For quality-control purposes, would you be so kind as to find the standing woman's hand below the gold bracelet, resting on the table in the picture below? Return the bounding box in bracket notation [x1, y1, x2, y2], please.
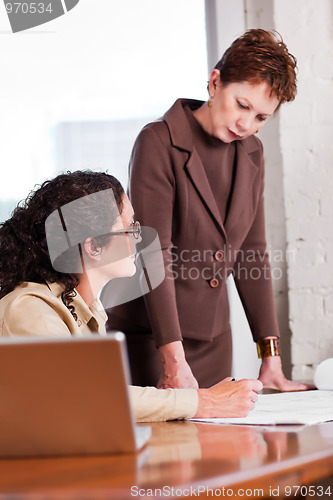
[259, 356, 316, 392]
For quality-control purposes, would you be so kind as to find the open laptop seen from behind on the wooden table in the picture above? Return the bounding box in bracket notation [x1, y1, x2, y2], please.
[0, 332, 151, 457]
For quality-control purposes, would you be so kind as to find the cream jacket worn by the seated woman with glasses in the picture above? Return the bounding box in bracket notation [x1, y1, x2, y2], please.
[0, 282, 198, 422]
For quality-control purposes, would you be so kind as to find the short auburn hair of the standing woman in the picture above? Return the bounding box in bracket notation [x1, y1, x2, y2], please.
[215, 29, 297, 107]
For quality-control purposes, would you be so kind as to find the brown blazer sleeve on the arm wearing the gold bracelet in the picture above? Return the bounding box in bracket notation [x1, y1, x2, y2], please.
[234, 150, 280, 341]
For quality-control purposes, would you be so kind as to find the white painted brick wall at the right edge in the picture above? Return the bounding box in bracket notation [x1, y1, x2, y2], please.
[274, 0, 333, 379]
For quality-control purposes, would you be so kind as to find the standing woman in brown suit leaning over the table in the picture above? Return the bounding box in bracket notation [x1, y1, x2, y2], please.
[109, 29, 307, 390]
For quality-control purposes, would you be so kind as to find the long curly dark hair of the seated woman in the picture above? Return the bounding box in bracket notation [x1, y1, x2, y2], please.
[0, 170, 124, 319]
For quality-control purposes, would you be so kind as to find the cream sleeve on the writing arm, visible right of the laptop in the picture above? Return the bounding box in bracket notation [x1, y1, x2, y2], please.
[129, 386, 199, 422]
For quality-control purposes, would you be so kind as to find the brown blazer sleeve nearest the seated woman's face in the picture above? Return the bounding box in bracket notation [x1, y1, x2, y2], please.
[129, 122, 182, 347]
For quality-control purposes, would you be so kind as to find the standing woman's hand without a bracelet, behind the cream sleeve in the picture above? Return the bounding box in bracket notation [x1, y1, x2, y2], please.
[157, 340, 199, 389]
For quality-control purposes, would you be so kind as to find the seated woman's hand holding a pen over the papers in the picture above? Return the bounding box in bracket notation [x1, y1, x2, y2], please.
[195, 377, 262, 418]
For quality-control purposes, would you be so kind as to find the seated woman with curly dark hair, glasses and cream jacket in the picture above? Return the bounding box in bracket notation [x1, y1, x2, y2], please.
[0, 171, 262, 421]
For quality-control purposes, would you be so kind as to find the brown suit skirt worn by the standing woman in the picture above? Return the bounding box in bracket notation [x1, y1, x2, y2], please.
[125, 330, 232, 388]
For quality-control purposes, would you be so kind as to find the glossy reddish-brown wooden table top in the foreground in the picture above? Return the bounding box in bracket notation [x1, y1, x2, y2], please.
[0, 421, 333, 500]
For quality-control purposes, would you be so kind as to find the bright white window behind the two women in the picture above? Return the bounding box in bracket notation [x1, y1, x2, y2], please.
[0, 0, 207, 220]
